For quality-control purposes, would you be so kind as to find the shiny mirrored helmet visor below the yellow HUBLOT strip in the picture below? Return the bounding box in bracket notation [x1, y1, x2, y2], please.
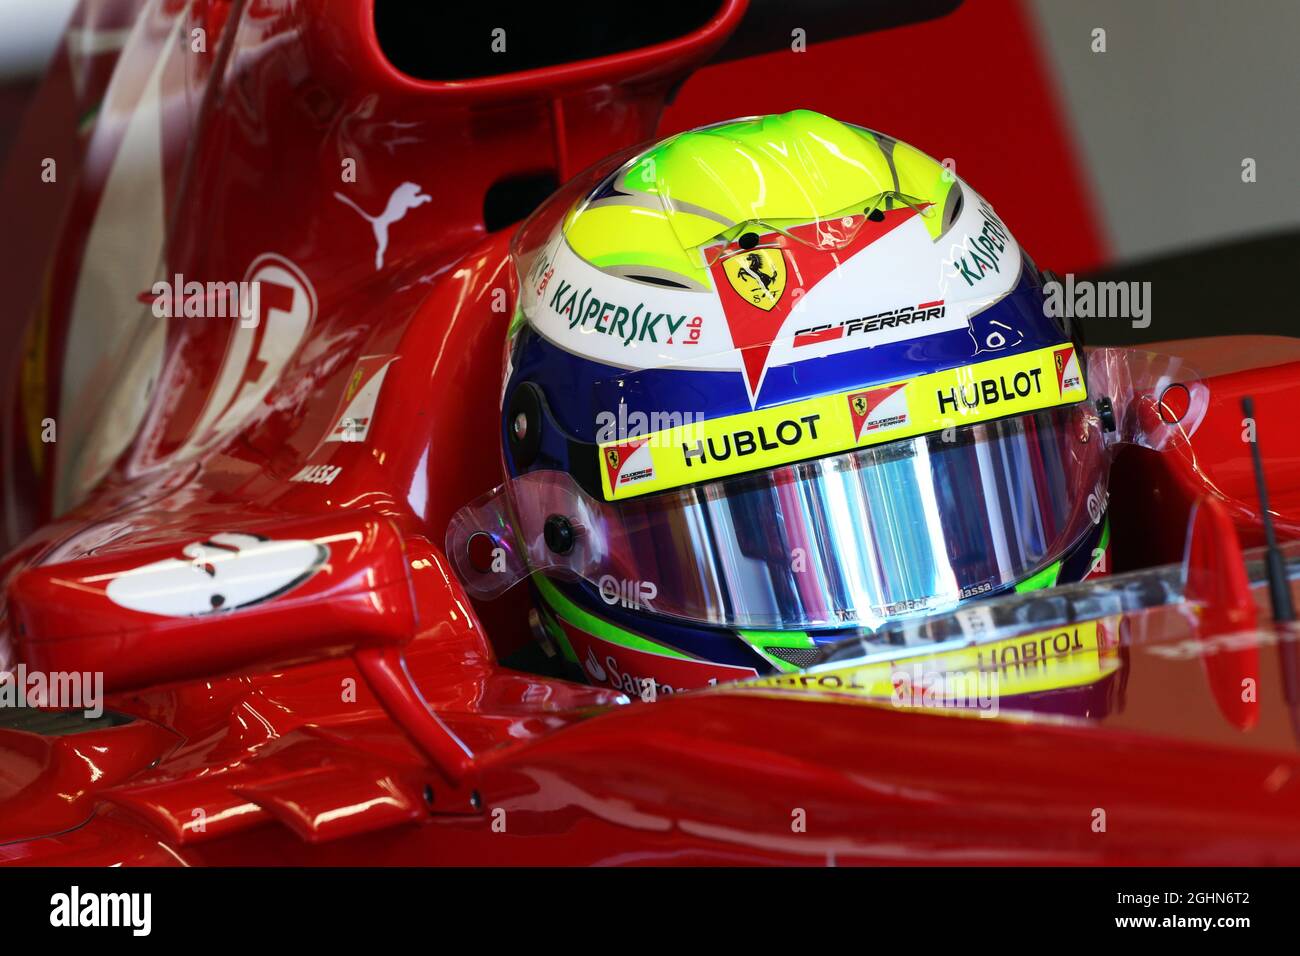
[447, 405, 1106, 630]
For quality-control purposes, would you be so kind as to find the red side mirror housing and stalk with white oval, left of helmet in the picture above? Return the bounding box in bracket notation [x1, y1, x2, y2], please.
[9, 511, 473, 803]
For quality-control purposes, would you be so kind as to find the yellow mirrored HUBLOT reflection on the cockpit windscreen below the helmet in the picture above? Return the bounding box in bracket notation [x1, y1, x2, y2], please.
[728, 620, 1119, 704]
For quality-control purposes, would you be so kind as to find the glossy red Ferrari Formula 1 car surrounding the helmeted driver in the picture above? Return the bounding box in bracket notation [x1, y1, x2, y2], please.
[0, 0, 1300, 866]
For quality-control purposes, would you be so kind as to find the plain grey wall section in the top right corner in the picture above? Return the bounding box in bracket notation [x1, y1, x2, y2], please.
[1029, 0, 1300, 260]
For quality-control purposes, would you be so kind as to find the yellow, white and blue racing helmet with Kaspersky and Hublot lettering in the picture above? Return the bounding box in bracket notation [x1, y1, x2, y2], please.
[446, 111, 1159, 695]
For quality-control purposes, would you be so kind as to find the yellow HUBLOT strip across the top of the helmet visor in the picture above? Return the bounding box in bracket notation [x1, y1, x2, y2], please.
[599, 345, 1088, 501]
